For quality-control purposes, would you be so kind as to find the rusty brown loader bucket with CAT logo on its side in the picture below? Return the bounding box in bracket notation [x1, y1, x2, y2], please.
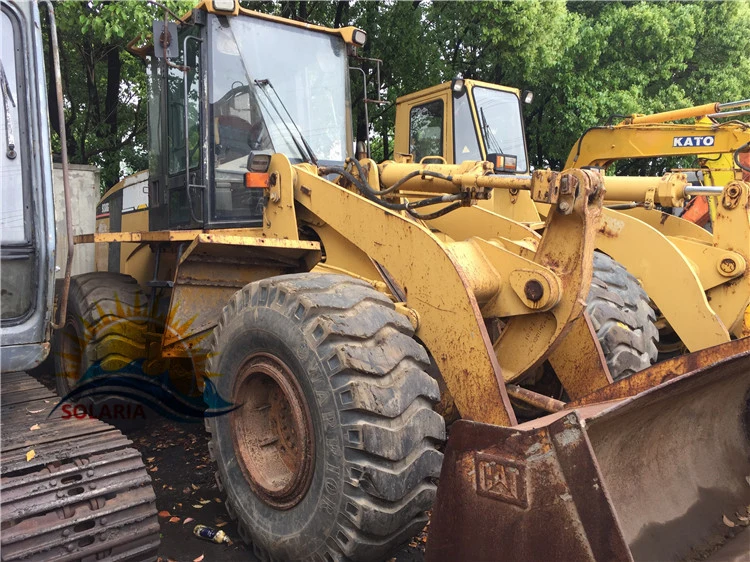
[427, 340, 750, 562]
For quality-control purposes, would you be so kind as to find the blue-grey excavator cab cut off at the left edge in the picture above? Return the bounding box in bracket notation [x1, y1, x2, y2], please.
[0, 1, 55, 373]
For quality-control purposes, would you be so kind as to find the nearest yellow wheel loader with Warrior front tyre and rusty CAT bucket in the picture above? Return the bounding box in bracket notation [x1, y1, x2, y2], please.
[60, 5, 750, 561]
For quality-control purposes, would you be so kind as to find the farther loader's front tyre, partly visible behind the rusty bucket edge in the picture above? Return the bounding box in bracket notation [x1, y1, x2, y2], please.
[586, 252, 659, 380]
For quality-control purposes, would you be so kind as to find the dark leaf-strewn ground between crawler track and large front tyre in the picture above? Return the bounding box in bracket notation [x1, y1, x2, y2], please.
[32, 365, 425, 562]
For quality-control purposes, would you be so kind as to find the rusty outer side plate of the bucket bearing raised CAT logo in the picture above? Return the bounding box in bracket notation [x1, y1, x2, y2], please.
[426, 414, 630, 562]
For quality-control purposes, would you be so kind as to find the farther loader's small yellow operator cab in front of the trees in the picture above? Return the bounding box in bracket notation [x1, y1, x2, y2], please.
[394, 78, 529, 173]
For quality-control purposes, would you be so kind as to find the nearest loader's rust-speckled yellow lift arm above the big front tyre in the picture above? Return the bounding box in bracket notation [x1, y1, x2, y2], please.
[295, 160, 515, 425]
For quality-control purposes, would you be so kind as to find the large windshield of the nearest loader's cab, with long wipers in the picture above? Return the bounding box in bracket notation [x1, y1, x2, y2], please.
[209, 16, 351, 221]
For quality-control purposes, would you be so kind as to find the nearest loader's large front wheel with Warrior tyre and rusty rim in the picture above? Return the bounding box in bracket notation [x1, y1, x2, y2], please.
[206, 273, 445, 561]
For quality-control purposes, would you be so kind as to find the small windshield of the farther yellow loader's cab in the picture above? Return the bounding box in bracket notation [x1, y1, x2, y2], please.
[472, 86, 528, 172]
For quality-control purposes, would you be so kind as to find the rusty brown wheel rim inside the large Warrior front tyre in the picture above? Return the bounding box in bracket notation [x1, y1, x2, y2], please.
[235, 353, 314, 509]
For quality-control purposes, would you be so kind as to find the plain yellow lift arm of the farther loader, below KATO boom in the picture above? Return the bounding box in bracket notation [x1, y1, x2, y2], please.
[596, 209, 729, 351]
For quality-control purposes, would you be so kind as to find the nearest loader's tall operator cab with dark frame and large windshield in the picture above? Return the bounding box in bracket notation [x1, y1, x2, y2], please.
[149, 2, 366, 230]
